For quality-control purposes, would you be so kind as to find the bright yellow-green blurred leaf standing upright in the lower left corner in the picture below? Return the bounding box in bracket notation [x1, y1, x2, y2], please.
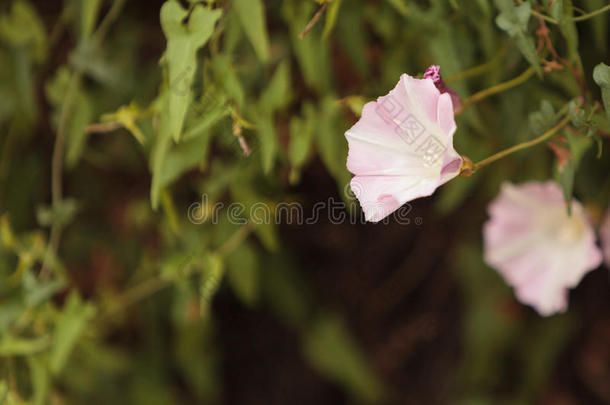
[49, 292, 95, 375]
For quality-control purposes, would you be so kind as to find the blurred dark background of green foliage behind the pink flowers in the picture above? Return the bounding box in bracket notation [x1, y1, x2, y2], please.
[0, 0, 610, 405]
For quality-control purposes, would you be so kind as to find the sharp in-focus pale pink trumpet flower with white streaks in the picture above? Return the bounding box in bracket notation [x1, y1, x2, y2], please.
[345, 68, 462, 222]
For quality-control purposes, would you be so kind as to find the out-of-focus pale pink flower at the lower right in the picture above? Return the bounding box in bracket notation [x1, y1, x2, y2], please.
[483, 181, 601, 316]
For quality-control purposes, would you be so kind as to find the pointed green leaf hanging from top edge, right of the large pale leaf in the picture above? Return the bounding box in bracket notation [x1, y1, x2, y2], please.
[233, 0, 269, 62]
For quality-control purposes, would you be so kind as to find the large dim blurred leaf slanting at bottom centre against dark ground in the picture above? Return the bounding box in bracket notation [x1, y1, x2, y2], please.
[303, 317, 383, 403]
